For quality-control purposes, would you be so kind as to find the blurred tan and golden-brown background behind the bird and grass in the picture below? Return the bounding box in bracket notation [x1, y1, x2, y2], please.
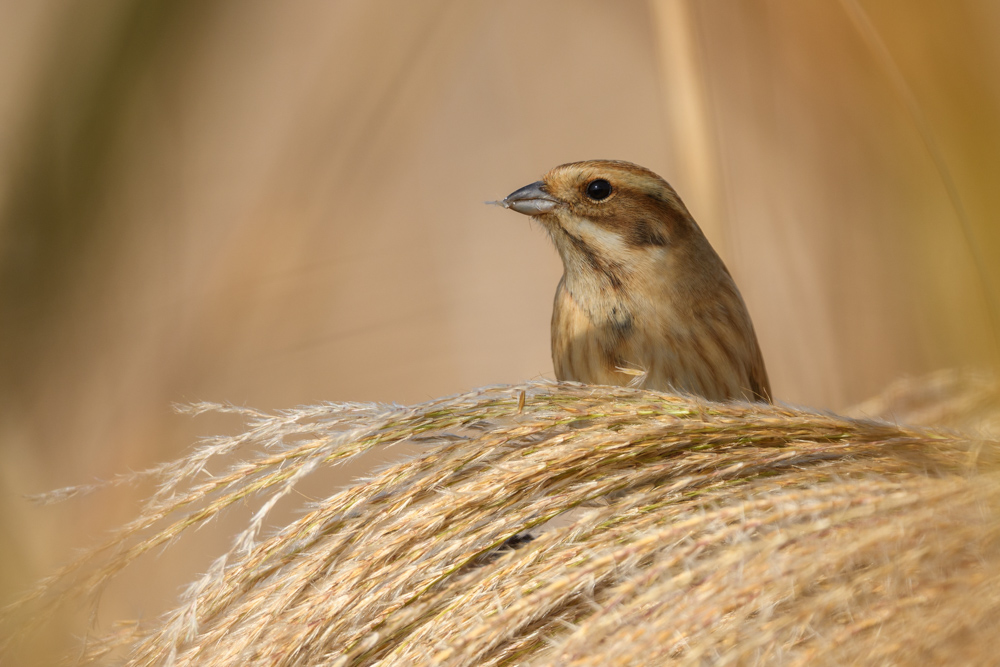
[0, 0, 1000, 664]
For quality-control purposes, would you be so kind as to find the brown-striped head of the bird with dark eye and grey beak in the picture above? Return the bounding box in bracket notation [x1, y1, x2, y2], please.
[500, 160, 714, 285]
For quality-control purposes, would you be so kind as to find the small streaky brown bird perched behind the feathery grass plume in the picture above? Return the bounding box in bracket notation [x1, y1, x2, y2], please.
[489, 160, 771, 403]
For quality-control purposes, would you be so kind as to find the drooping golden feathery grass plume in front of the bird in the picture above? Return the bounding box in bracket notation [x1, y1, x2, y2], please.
[5, 379, 1000, 666]
